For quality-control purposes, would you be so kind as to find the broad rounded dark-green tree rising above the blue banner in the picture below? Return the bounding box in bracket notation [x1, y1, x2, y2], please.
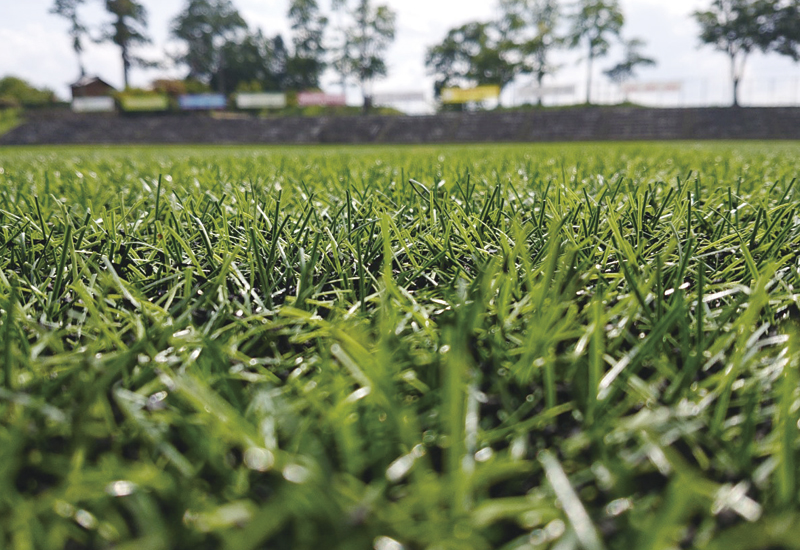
[171, 0, 247, 93]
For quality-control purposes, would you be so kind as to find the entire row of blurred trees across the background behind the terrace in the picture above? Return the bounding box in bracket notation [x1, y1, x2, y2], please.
[51, 0, 800, 106]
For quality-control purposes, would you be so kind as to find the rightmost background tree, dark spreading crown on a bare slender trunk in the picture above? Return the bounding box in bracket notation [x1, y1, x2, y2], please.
[694, 0, 800, 107]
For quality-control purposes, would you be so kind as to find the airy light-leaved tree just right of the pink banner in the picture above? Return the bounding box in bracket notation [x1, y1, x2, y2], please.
[333, 0, 397, 111]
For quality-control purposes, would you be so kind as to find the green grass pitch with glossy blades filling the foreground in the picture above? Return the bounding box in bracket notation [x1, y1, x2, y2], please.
[0, 143, 800, 550]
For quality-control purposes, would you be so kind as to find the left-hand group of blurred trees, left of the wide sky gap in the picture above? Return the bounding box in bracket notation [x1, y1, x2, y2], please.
[51, 0, 396, 105]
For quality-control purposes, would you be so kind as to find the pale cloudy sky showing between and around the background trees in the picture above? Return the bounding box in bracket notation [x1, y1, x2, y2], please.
[0, 0, 800, 112]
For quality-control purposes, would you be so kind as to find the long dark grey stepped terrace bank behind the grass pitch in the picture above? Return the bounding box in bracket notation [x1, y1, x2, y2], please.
[0, 107, 800, 145]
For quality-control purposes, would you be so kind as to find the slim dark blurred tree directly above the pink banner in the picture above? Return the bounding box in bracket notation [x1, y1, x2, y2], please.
[286, 0, 328, 90]
